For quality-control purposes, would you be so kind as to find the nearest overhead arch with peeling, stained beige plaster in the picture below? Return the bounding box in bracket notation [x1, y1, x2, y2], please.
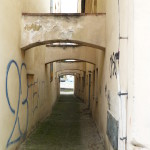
[21, 14, 105, 50]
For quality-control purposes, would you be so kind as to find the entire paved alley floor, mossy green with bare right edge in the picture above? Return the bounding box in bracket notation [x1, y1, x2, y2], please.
[19, 95, 104, 150]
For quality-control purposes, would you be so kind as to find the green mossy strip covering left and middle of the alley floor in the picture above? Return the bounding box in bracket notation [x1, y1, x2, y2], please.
[20, 96, 81, 150]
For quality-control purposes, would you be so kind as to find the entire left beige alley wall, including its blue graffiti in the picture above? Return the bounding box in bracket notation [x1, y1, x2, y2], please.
[0, 0, 57, 150]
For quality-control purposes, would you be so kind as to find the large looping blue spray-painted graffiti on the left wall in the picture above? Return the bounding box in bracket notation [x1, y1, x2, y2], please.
[6, 60, 28, 147]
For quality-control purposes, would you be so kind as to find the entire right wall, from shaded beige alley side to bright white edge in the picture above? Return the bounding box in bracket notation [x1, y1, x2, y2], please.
[86, 0, 150, 150]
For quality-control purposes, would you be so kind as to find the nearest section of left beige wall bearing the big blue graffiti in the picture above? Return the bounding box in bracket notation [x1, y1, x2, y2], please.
[0, 0, 24, 149]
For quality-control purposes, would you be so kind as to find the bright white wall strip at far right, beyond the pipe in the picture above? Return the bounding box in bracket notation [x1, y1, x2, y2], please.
[131, 0, 150, 149]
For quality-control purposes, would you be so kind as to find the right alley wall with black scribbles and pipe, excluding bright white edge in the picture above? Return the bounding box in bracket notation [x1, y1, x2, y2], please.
[84, 0, 130, 150]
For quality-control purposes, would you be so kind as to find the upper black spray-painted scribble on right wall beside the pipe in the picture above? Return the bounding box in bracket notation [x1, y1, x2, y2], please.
[109, 53, 118, 78]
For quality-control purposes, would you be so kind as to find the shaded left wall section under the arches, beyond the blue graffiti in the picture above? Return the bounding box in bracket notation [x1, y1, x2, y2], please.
[25, 46, 57, 135]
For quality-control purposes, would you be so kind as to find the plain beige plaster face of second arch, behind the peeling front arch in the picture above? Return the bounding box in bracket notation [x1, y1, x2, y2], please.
[45, 46, 96, 64]
